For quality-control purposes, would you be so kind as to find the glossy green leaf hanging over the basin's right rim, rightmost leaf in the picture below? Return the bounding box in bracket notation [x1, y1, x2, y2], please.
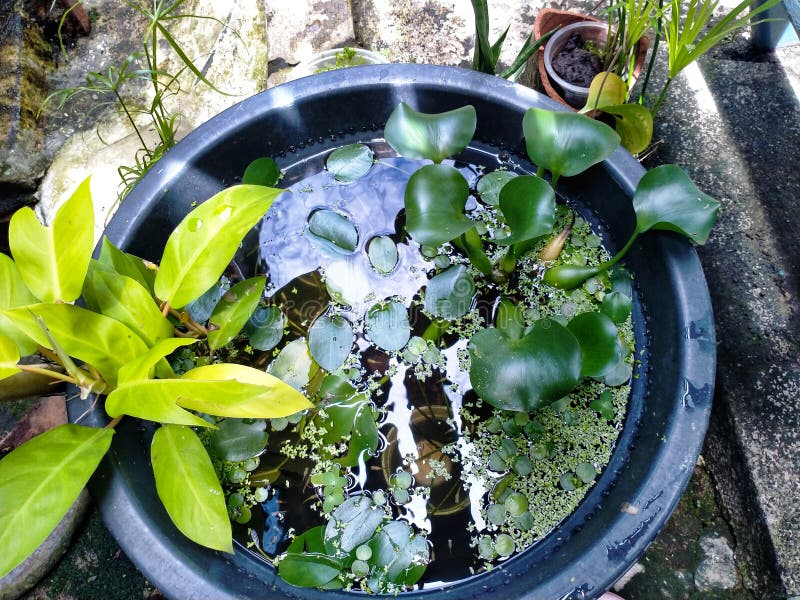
[633, 165, 719, 244]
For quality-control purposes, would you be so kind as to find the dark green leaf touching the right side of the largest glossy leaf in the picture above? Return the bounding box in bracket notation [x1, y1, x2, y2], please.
[567, 312, 622, 377]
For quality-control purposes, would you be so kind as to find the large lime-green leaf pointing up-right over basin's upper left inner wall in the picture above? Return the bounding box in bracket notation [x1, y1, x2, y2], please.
[154, 185, 283, 308]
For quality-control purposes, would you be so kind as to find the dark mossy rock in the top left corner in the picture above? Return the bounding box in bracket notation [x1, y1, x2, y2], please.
[0, 0, 53, 190]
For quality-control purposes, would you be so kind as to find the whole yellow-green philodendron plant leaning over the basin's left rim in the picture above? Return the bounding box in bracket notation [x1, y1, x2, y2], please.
[0, 180, 311, 577]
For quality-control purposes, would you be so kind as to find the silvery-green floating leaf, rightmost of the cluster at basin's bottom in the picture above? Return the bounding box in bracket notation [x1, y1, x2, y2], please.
[369, 521, 430, 585]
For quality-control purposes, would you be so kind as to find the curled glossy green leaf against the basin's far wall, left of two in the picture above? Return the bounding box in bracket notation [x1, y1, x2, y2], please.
[383, 102, 478, 163]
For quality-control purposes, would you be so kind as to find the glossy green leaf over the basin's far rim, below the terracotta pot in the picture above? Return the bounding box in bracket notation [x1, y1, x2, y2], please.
[522, 108, 619, 179]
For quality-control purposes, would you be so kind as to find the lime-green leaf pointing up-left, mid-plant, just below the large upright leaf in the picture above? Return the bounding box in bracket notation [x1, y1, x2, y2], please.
[92, 270, 174, 347]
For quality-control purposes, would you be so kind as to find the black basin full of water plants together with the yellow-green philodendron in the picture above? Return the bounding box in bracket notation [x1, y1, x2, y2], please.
[0, 65, 717, 598]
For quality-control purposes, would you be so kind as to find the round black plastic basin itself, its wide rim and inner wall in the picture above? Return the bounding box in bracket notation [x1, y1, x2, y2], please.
[70, 65, 715, 600]
